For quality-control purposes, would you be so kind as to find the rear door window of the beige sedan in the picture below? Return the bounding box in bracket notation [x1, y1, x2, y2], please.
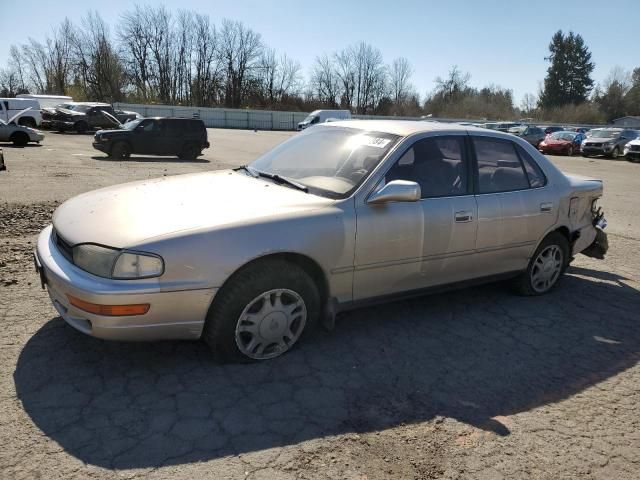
[473, 137, 529, 193]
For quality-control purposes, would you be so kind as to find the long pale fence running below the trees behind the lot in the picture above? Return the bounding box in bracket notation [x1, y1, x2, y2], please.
[113, 103, 600, 130]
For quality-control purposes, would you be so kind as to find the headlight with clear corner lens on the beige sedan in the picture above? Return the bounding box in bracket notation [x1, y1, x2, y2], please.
[73, 244, 164, 280]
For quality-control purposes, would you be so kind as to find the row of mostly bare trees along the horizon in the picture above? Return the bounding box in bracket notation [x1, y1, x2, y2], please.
[0, 9, 640, 123]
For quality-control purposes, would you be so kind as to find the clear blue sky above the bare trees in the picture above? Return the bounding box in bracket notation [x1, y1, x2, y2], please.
[0, 0, 640, 103]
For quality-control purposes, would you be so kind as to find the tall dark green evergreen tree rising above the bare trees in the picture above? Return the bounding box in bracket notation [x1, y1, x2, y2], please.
[540, 30, 595, 108]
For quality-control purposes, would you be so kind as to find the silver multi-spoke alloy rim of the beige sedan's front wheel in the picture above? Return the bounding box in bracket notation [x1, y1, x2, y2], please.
[235, 288, 307, 360]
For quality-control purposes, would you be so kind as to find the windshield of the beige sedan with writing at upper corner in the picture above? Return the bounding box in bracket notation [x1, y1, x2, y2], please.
[250, 125, 400, 198]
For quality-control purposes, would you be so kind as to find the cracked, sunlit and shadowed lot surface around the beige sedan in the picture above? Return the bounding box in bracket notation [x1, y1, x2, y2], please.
[0, 130, 640, 480]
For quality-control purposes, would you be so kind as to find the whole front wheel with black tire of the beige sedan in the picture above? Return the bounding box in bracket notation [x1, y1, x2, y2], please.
[202, 259, 321, 363]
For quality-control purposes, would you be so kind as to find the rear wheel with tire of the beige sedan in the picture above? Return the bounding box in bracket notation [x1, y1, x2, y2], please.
[515, 232, 570, 296]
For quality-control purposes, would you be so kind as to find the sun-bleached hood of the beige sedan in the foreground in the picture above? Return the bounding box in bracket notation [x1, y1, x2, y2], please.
[53, 170, 335, 248]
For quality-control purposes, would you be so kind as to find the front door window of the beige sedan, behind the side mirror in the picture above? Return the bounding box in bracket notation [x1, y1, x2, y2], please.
[385, 136, 468, 198]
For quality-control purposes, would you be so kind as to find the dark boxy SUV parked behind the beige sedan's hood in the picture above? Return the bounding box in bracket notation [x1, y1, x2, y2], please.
[93, 118, 209, 160]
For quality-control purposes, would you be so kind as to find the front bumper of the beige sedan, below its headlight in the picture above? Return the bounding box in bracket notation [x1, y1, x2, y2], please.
[35, 226, 217, 340]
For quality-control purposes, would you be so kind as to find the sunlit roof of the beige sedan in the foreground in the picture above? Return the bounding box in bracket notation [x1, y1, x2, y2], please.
[324, 120, 490, 138]
